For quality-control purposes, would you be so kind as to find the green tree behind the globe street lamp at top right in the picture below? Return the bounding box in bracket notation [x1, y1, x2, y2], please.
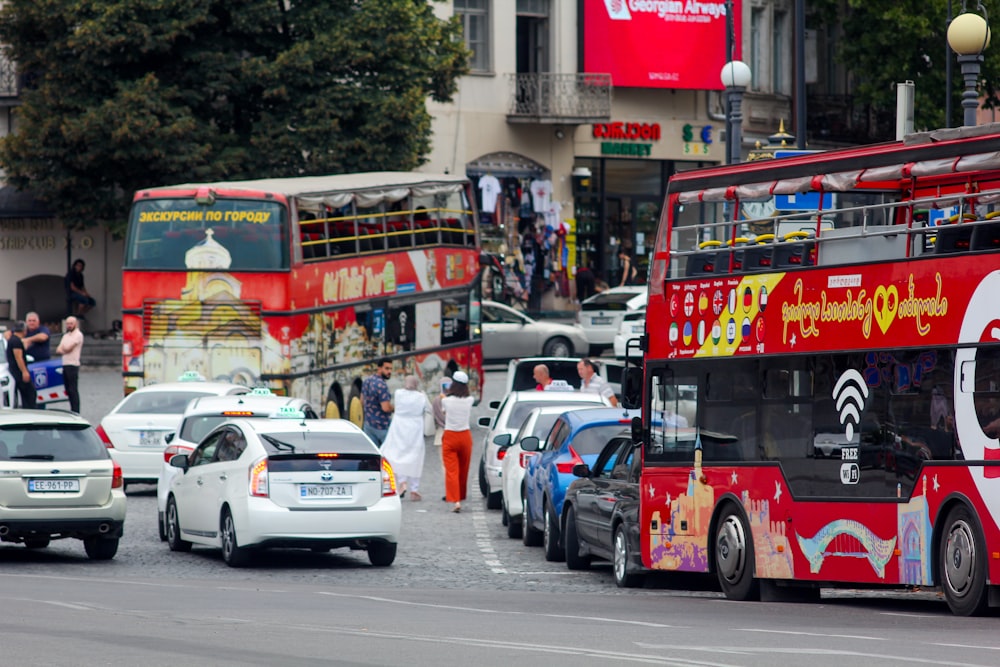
[810, 0, 1000, 139]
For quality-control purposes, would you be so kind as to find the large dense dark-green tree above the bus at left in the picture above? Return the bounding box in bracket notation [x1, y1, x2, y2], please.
[0, 0, 468, 233]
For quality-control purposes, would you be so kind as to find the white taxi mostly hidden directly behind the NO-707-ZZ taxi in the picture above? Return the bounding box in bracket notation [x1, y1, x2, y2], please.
[156, 387, 319, 540]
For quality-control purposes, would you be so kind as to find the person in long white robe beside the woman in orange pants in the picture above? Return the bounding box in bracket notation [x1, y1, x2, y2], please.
[382, 375, 431, 500]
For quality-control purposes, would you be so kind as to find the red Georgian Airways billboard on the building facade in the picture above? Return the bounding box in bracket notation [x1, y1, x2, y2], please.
[582, 0, 742, 90]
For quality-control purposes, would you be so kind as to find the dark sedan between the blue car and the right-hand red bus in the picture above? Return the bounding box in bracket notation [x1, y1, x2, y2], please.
[563, 431, 644, 588]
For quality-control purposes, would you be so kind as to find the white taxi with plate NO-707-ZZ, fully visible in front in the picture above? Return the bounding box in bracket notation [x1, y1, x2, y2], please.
[167, 410, 402, 567]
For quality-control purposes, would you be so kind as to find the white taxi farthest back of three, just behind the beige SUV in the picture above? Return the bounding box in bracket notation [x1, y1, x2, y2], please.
[97, 373, 250, 485]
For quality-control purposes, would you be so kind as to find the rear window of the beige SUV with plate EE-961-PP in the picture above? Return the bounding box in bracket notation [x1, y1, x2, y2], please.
[0, 424, 109, 461]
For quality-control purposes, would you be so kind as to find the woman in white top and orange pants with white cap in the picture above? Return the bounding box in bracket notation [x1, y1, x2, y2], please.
[441, 371, 473, 512]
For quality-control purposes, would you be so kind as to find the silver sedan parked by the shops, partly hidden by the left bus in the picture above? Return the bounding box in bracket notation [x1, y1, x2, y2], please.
[482, 301, 590, 359]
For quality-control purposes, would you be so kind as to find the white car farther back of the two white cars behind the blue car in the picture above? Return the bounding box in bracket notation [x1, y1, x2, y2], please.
[479, 385, 610, 510]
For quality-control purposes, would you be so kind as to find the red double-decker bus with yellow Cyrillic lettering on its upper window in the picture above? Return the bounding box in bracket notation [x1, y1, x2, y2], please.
[123, 172, 483, 423]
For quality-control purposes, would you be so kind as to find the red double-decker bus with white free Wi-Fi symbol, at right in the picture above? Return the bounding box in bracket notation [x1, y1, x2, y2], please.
[638, 125, 1000, 615]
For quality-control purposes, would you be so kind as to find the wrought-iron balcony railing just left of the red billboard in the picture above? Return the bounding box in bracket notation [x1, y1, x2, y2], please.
[507, 73, 611, 125]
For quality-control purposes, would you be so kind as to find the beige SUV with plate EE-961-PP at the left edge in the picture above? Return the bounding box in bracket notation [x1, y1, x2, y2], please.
[0, 410, 125, 560]
